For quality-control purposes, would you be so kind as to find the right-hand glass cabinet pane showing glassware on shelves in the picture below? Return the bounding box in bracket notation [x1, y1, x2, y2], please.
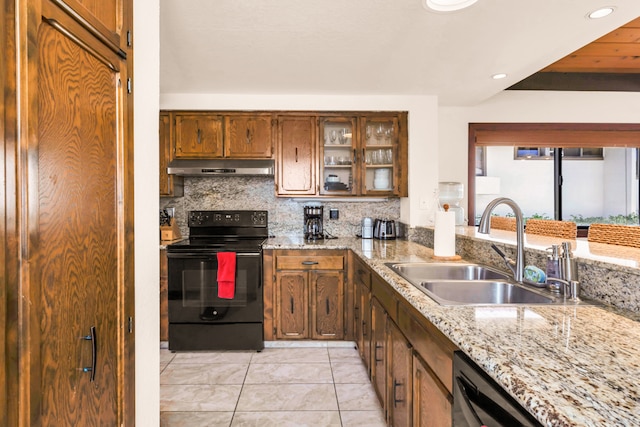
[363, 118, 398, 194]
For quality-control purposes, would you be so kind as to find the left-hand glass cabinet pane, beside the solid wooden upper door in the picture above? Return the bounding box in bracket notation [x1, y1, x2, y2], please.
[320, 118, 356, 195]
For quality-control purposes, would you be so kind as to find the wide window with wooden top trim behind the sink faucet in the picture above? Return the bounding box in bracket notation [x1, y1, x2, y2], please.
[468, 124, 640, 228]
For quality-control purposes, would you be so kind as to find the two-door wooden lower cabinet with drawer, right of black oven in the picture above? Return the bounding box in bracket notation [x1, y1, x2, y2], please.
[264, 250, 346, 340]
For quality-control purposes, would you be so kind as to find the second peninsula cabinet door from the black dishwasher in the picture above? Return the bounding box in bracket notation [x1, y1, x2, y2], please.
[388, 322, 413, 427]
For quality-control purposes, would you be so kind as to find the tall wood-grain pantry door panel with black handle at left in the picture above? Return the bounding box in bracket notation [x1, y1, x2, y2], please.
[37, 18, 122, 426]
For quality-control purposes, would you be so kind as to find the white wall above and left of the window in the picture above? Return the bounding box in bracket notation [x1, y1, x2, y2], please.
[438, 91, 640, 222]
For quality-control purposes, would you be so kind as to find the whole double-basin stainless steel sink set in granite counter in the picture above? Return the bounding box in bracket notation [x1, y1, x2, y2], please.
[386, 262, 592, 305]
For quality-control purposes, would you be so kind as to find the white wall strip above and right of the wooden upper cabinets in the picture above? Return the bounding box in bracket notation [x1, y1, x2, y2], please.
[160, 94, 438, 225]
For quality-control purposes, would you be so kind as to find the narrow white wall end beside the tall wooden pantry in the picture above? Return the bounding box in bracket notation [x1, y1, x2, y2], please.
[133, 0, 160, 426]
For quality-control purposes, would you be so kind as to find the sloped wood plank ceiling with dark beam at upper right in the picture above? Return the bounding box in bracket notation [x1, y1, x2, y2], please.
[509, 18, 640, 92]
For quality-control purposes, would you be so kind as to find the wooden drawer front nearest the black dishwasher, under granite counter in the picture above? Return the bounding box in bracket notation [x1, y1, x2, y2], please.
[398, 307, 457, 393]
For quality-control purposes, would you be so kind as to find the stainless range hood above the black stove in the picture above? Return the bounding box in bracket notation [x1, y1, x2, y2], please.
[167, 159, 275, 176]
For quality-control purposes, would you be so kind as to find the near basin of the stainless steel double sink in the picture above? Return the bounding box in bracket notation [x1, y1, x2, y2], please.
[418, 280, 564, 305]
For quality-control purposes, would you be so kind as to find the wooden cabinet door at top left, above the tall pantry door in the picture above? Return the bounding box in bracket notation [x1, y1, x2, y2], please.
[49, 0, 131, 53]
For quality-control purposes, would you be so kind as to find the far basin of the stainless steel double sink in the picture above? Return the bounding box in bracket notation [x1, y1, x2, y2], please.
[386, 262, 509, 284]
